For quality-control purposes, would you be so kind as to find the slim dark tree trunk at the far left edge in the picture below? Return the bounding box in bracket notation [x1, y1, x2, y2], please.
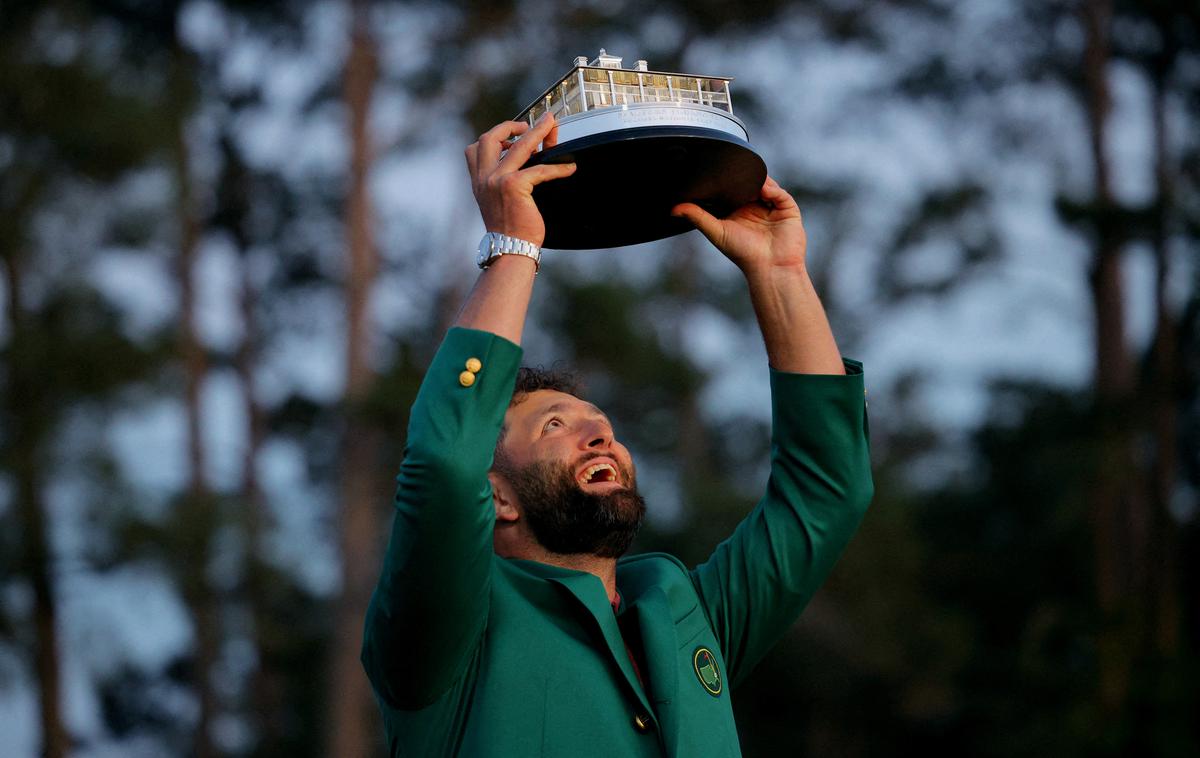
[4, 251, 70, 758]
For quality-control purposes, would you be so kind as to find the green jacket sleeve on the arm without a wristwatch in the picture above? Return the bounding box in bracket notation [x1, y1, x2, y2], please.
[691, 361, 874, 685]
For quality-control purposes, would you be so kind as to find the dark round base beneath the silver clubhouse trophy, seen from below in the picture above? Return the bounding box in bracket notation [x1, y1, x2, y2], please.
[526, 126, 767, 249]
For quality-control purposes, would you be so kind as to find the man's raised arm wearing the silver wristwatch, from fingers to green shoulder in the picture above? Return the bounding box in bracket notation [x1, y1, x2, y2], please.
[362, 120, 574, 709]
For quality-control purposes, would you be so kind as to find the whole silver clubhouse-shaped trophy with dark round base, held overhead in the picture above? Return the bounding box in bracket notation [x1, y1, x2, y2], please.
[516, 49, 767, 249]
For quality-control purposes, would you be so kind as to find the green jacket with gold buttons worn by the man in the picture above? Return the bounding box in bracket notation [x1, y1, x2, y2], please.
[362, 329, 872, 758]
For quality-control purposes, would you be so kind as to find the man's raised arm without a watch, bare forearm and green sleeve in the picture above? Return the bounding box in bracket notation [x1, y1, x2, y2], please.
[674, 178, 872, 685]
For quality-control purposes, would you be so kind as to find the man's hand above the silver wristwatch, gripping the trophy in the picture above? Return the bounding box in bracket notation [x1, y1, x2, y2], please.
[466, 113, 575, 246]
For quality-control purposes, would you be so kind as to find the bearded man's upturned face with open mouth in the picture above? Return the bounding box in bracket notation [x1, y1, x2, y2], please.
[496, 390, 646, 558]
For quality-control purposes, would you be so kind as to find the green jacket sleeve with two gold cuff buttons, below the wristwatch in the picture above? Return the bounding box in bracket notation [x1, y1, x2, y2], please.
[362, 329, 521, 709]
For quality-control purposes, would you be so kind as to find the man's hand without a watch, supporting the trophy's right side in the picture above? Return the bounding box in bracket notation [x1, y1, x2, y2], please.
[671, 176, 808, 275]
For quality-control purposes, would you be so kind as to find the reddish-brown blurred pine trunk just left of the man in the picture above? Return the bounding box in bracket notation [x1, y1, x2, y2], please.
[325, 0, 384, 756]
